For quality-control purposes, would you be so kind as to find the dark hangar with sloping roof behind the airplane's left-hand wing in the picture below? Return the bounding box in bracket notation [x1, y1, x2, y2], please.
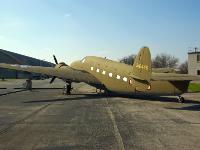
[0, 49, 55, 78]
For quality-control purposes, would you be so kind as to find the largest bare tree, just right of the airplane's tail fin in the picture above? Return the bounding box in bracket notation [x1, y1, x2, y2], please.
[152, 54, 178, 68]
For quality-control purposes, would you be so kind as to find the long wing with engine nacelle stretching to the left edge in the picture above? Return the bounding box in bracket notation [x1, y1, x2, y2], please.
[0, 63, 98, 83]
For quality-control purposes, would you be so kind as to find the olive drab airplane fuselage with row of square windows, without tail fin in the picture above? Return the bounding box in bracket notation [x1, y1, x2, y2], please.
[71, 56, 189, 95]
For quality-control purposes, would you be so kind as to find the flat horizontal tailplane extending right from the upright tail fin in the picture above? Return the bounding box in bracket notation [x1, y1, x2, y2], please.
[151, 73, 200, 81]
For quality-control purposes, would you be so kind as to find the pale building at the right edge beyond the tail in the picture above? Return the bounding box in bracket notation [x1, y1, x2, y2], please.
[188, 48, 200, 75]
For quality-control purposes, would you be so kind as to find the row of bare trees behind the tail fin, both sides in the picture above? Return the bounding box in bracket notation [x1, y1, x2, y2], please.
[119, 53, 188, 74]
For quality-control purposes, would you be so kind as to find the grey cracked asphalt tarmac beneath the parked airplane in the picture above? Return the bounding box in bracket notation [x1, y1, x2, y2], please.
[0, 80, 200, 150]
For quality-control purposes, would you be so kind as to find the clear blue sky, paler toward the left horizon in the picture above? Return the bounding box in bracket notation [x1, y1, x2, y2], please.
[0, 0, 200, 64]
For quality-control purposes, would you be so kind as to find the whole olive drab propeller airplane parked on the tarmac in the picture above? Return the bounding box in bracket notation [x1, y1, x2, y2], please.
[0, 47, 200, 102]
